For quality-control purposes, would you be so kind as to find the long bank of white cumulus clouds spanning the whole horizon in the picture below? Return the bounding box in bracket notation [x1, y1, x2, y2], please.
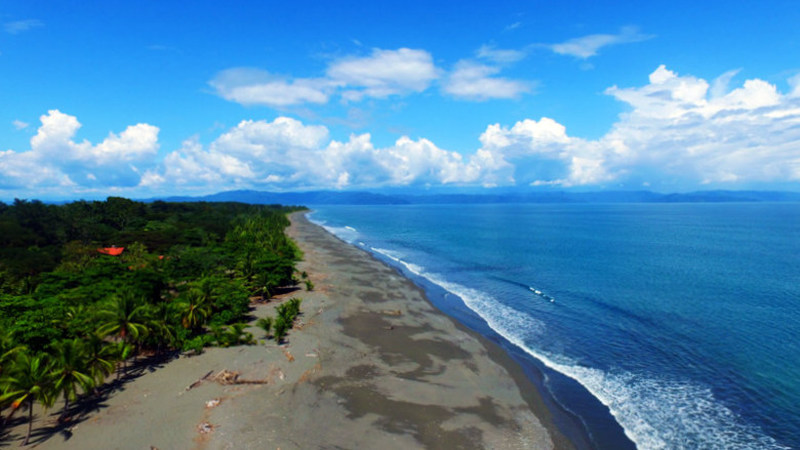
[0, 65, 800, 197]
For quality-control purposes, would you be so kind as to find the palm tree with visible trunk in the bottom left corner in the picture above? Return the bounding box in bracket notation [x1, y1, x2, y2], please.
[0, 352, 55, 445]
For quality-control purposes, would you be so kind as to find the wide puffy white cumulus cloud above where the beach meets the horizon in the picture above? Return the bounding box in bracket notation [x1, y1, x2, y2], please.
[142, 117, 477, 189]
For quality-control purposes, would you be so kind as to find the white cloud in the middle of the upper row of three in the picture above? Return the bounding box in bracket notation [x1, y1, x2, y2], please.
[327, 48, 438, 101]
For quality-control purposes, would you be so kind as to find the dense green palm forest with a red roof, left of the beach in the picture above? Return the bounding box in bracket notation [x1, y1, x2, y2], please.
[0, 197, 305, 444]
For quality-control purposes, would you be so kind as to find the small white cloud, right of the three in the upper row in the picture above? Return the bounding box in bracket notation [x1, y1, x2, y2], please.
[442, 61, 530, 101]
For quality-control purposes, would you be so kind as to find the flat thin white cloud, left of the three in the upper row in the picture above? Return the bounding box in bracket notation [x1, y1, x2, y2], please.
[209, 68, 332, 107]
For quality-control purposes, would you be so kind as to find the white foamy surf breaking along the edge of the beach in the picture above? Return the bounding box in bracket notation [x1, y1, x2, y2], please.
[370, 247, 788, 449]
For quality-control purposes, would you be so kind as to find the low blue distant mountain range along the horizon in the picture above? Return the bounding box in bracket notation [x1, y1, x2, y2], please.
[145, 190, 800, 205]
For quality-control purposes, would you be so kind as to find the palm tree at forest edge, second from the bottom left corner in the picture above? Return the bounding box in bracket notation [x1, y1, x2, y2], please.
[52, 338, 94, 421]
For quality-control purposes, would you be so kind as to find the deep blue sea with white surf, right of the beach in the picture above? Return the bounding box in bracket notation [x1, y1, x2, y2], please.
[310, 203, 800, 449]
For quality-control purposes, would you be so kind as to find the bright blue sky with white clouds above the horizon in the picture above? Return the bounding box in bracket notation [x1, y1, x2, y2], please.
[0, 0, 800, 201]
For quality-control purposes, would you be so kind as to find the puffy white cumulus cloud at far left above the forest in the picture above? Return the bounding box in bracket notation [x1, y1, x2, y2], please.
[0, 110, 159, 189]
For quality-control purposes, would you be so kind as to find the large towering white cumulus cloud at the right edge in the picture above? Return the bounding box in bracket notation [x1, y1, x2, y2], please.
[472, 65, 800, 189]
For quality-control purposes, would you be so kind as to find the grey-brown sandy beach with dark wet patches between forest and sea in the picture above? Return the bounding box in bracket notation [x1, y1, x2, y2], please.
[17, 213, 571, 450]
